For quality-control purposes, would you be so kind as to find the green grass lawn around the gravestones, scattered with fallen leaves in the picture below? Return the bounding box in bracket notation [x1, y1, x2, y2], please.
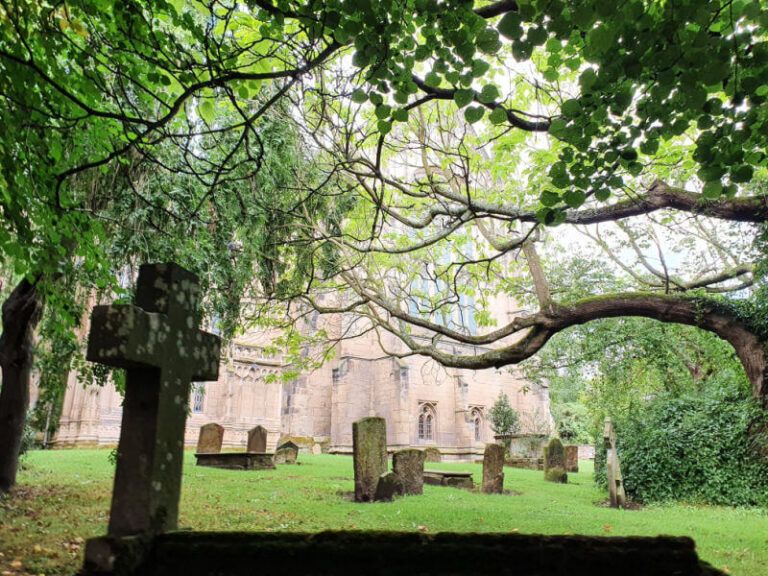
[0, 450, 768, 576]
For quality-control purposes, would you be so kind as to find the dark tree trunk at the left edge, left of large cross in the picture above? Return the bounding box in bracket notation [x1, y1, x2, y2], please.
[0, 279, 43, 494]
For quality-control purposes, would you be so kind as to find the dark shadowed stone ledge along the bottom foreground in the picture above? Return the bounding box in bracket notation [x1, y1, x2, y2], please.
[91, 532, 722, 576]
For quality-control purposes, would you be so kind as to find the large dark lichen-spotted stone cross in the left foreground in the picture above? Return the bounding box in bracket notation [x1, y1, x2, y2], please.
[87, 264, 220, 537]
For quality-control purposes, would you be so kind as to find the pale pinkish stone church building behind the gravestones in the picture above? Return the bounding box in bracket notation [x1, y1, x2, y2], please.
[55, 302, 551, 460]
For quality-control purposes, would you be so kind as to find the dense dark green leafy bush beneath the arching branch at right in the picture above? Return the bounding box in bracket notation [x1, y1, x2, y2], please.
[595, 386, 768, 506]
